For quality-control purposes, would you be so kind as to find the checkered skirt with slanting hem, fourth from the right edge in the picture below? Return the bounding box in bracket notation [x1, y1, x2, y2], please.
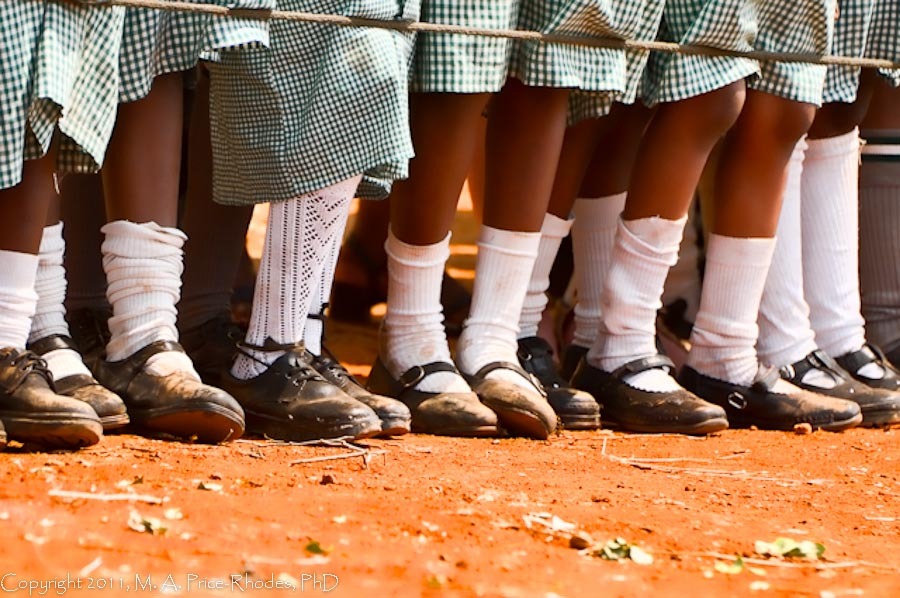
[642, 0, 764, 106]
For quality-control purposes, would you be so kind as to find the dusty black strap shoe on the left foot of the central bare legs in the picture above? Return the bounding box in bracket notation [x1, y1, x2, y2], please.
[366, 357, 500, 437]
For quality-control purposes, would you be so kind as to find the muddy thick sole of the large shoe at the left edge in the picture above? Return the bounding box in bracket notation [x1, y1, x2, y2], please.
[0, 413, 103, 449]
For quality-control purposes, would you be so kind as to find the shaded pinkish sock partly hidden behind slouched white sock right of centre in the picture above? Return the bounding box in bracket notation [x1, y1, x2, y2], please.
[572, 193, 625, 347]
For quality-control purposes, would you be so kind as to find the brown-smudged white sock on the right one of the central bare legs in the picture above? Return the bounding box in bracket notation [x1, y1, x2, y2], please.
[456, 225, 541, 392]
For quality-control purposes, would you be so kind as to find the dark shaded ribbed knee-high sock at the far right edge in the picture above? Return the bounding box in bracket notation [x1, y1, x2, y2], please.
[859, 154, 900, 351]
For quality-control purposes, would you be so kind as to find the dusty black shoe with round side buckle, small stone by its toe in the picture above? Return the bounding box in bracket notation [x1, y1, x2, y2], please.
[678, 366, 862, 432]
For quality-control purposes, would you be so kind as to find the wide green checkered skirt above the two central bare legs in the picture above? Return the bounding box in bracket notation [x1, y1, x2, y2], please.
[411, 0, 657, 93]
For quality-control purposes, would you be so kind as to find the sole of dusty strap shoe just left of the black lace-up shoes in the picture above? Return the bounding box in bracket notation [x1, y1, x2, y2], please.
[131, 403, 244, 444]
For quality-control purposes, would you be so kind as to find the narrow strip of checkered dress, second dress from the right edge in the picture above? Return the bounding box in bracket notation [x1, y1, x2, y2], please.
[822, 0, 877, 104]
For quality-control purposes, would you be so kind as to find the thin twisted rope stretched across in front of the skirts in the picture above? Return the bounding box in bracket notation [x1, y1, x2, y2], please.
[82, 0, 900, 70]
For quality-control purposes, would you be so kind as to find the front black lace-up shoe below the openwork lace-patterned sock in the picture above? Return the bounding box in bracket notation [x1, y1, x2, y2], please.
[222, 341, 381, 442]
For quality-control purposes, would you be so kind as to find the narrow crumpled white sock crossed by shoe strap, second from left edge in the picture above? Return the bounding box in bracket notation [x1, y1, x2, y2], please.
[28, 222, 91, 380]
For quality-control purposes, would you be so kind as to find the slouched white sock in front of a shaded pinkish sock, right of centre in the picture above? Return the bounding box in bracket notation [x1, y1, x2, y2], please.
[587, 217, 687, 392]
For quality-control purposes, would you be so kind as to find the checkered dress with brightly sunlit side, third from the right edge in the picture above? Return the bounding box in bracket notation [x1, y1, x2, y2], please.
[748, 0, 837, 105]
